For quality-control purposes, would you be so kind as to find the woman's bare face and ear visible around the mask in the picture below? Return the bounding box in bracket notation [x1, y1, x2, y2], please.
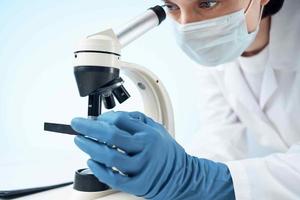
[163, 0, 269, 32]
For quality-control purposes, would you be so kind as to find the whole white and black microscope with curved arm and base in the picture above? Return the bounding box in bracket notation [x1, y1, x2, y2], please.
[44, 6, 175, 200]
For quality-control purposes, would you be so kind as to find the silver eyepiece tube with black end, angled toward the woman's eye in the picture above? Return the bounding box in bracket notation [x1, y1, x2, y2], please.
[114, 6, 166, 48]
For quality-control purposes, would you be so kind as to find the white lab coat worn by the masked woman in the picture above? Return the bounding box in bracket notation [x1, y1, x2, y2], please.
[187, 0, 300, 200]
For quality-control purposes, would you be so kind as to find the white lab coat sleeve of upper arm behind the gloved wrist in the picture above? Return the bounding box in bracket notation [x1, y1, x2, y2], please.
[185, 69, 247, 161]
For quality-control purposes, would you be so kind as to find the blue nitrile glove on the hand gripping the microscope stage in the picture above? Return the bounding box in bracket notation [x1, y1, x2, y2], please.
[72, 112, 235, 200]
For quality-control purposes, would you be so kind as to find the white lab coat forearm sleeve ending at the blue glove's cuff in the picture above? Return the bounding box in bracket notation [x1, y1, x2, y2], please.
[226, 142, 300, 200]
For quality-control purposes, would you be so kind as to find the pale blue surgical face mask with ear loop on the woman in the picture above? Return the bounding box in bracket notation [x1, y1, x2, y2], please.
[174, 1, 263, 66]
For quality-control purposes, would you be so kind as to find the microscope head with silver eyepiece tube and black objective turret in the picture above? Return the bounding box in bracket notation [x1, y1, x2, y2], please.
[74, 6, 166, 114]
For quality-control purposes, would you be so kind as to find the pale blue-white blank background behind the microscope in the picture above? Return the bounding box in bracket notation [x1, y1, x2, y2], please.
[0, 0, 203, 188]
